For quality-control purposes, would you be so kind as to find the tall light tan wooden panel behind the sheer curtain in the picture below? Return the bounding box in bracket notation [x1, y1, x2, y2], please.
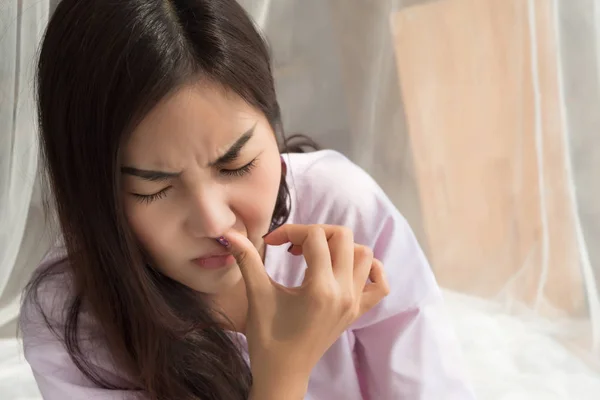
[392, 0, 585, 315]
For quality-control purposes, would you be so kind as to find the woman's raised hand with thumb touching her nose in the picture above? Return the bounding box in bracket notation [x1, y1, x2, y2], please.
[225, 225, 389, 396]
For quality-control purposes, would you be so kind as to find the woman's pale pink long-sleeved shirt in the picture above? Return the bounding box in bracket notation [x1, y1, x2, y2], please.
[21, 150, 474, 400]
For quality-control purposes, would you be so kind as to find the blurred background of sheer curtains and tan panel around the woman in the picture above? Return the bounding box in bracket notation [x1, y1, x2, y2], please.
[0, 0, 600, 400]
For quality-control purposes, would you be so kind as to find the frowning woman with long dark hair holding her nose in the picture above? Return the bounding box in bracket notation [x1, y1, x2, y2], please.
[21, 0, 472, 400]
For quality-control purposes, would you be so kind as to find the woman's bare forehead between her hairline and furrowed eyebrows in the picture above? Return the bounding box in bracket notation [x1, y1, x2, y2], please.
[123, 84, 261, 168]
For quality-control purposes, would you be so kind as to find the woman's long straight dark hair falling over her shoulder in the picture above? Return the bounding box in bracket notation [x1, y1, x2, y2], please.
[26, 0, 314, 400]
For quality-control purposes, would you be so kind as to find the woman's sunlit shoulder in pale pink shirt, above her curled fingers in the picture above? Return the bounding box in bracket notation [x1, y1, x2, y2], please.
[285, 150, 408, 245]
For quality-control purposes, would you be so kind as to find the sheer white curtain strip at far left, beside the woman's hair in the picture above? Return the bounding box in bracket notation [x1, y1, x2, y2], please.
[0, 0, 49, 336]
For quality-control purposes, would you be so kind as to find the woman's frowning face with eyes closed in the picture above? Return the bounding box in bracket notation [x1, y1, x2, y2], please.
[121, 84, 281, 295]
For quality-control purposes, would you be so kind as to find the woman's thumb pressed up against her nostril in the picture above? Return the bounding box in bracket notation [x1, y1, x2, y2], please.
[223, 230, 271, 295]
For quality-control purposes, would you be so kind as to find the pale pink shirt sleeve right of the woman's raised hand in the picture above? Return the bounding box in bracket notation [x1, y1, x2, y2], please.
[304, 151, 475, 400]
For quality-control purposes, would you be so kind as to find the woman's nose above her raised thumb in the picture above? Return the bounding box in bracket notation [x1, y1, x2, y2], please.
[187, 187, 236, 238]
